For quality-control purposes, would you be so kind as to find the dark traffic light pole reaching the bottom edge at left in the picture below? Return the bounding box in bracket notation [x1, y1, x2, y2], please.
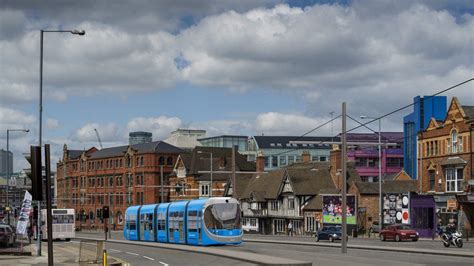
[44, 144, 54, 266]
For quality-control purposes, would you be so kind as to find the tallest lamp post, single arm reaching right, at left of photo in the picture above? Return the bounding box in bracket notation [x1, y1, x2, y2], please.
[36, 30, 86, 260]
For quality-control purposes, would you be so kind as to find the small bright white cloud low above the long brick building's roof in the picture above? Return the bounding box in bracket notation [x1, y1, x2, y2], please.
[126, 115, 182, 140]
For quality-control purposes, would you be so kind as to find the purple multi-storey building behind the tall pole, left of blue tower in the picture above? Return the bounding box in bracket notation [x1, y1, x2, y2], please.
[347, 132, 403, 182]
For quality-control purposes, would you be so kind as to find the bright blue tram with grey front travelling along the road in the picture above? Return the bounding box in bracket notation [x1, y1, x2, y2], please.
[123, 197, 242, 246]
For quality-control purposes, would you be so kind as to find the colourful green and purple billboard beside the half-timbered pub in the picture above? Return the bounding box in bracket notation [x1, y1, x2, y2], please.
[322, 195, 357, 224]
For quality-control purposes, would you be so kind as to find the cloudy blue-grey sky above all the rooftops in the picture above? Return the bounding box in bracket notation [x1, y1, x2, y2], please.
[0, 0, 474, 171]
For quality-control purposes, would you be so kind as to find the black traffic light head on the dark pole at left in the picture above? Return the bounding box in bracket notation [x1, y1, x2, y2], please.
[25, 146, 43, 201]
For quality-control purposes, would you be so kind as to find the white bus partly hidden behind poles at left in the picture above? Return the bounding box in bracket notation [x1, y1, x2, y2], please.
[41, 209, 76, 241]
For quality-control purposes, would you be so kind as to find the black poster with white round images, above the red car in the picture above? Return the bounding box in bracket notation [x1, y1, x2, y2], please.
[383, 193, 410, 224]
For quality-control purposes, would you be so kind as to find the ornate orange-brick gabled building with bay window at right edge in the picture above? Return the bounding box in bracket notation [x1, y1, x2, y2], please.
[418, 97, 474, 234]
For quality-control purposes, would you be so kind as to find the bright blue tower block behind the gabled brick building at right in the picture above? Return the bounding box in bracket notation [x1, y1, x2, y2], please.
[403, 96, 447, 179]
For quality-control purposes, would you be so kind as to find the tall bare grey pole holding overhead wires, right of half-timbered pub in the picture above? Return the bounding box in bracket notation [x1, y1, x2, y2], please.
[341, 102, 347, 254]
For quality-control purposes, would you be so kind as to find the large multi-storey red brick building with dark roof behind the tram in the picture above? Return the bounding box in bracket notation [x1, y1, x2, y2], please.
[56, 141, 183, 229]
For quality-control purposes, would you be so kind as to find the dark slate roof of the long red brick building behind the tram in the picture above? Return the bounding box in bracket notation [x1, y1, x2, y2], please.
[90, 141, 183, 159]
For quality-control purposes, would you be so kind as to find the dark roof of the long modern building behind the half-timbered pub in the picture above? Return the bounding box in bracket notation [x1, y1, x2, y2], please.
[253, 136, 340, 149]
